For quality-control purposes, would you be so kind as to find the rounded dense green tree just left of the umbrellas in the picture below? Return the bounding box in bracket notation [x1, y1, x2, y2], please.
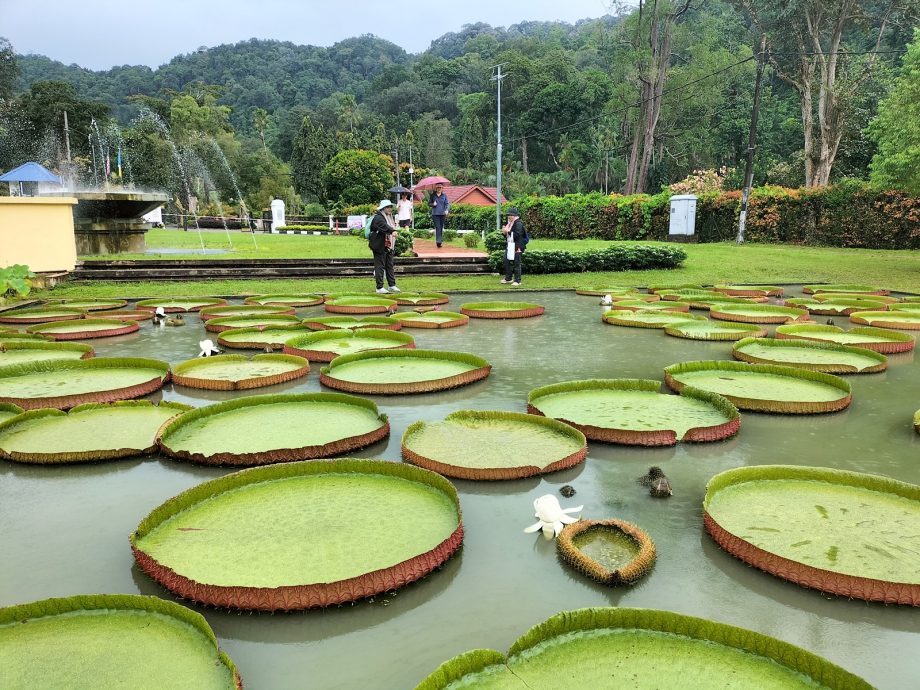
[322, 149, 395, 205]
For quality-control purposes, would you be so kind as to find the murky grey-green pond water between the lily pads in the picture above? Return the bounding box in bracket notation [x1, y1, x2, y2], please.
[0, 290, 920, 690]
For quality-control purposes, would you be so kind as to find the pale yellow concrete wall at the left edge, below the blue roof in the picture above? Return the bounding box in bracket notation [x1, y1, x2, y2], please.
[0, 197, 77, 272]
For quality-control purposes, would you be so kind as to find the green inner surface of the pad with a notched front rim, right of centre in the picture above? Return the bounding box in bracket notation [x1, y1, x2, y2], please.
[533, 390, 728, 439]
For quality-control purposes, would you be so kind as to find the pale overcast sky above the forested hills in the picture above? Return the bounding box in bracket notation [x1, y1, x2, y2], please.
[0, 0, 610, 70]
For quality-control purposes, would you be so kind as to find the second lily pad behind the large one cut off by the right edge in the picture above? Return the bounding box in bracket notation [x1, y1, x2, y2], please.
[732, 338, 888, 374]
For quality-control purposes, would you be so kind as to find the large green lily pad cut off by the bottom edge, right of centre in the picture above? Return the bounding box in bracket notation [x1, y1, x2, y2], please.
[415, 608, 872, 690]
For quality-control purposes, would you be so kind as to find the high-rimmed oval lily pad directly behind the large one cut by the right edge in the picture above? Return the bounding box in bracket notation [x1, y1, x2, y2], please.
[664, 361, 852, 414]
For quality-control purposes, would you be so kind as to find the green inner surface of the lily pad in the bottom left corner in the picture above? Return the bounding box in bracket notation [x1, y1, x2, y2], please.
[0, 610, 234, 690]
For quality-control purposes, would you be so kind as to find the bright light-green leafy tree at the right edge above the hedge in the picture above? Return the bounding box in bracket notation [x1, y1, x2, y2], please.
[869, 29, 920, 194]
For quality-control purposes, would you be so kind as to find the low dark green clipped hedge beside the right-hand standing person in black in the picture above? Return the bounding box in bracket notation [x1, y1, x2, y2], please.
[489, 244, 687, 274]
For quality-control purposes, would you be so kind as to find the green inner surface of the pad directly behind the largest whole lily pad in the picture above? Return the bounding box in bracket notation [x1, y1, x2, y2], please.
[163, 402, 383, 455]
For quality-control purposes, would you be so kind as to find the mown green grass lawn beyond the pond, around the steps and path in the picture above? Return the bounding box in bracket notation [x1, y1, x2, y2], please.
[35, 230, 920, 297]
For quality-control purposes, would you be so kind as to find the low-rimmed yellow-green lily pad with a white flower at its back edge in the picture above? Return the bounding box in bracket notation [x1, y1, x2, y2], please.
[172, 354, 310, 391]
